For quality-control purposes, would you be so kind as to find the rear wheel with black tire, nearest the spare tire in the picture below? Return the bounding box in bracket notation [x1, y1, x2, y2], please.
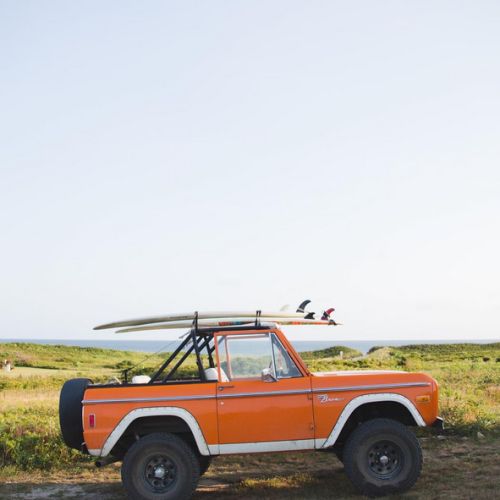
[122, 432, 200, 500]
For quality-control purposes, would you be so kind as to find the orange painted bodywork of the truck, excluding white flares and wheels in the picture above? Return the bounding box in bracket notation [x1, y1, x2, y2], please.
[83, 329, 438, 456]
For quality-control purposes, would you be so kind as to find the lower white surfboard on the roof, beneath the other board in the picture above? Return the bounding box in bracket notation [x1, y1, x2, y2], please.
[116, 317, 339, 333]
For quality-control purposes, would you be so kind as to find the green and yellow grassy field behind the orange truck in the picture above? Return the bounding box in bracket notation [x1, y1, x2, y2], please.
[0, 343, 500, 473]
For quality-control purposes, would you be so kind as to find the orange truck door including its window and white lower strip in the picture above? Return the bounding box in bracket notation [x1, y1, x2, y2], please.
[216, 331, 314, 453]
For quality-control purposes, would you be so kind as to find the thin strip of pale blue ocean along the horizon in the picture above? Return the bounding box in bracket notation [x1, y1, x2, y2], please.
[0, 338, 499, 354]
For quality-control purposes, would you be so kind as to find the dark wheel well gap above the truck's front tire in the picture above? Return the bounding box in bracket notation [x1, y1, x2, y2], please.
[333, 401, 418, 451]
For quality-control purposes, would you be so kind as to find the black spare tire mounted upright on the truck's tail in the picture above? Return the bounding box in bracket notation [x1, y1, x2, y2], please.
[59, 378, 92, 451]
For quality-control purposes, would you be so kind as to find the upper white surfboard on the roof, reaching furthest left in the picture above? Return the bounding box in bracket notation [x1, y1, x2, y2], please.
[94, 311, 309, 330]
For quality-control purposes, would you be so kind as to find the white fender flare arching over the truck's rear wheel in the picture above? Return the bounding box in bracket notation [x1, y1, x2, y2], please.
[89, 406, 210, 457]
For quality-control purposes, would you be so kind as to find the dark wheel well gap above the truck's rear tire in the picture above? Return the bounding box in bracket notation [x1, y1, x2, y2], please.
[110, 415, 198, 459]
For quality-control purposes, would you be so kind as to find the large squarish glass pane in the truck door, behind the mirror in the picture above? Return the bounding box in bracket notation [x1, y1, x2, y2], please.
[218, 333, 275, 380]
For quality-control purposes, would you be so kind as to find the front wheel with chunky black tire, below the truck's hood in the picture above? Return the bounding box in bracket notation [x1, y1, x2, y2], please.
[343, 418, 422, 497]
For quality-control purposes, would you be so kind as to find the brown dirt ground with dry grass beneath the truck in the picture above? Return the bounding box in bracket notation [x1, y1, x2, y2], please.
[0, 436, 500, 500]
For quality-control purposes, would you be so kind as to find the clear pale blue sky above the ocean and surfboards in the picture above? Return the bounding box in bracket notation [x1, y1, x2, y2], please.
[0, 0, 500, 340]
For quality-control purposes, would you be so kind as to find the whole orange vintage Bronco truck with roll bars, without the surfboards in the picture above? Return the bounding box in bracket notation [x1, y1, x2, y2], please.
[59, 321, 442, 500]
